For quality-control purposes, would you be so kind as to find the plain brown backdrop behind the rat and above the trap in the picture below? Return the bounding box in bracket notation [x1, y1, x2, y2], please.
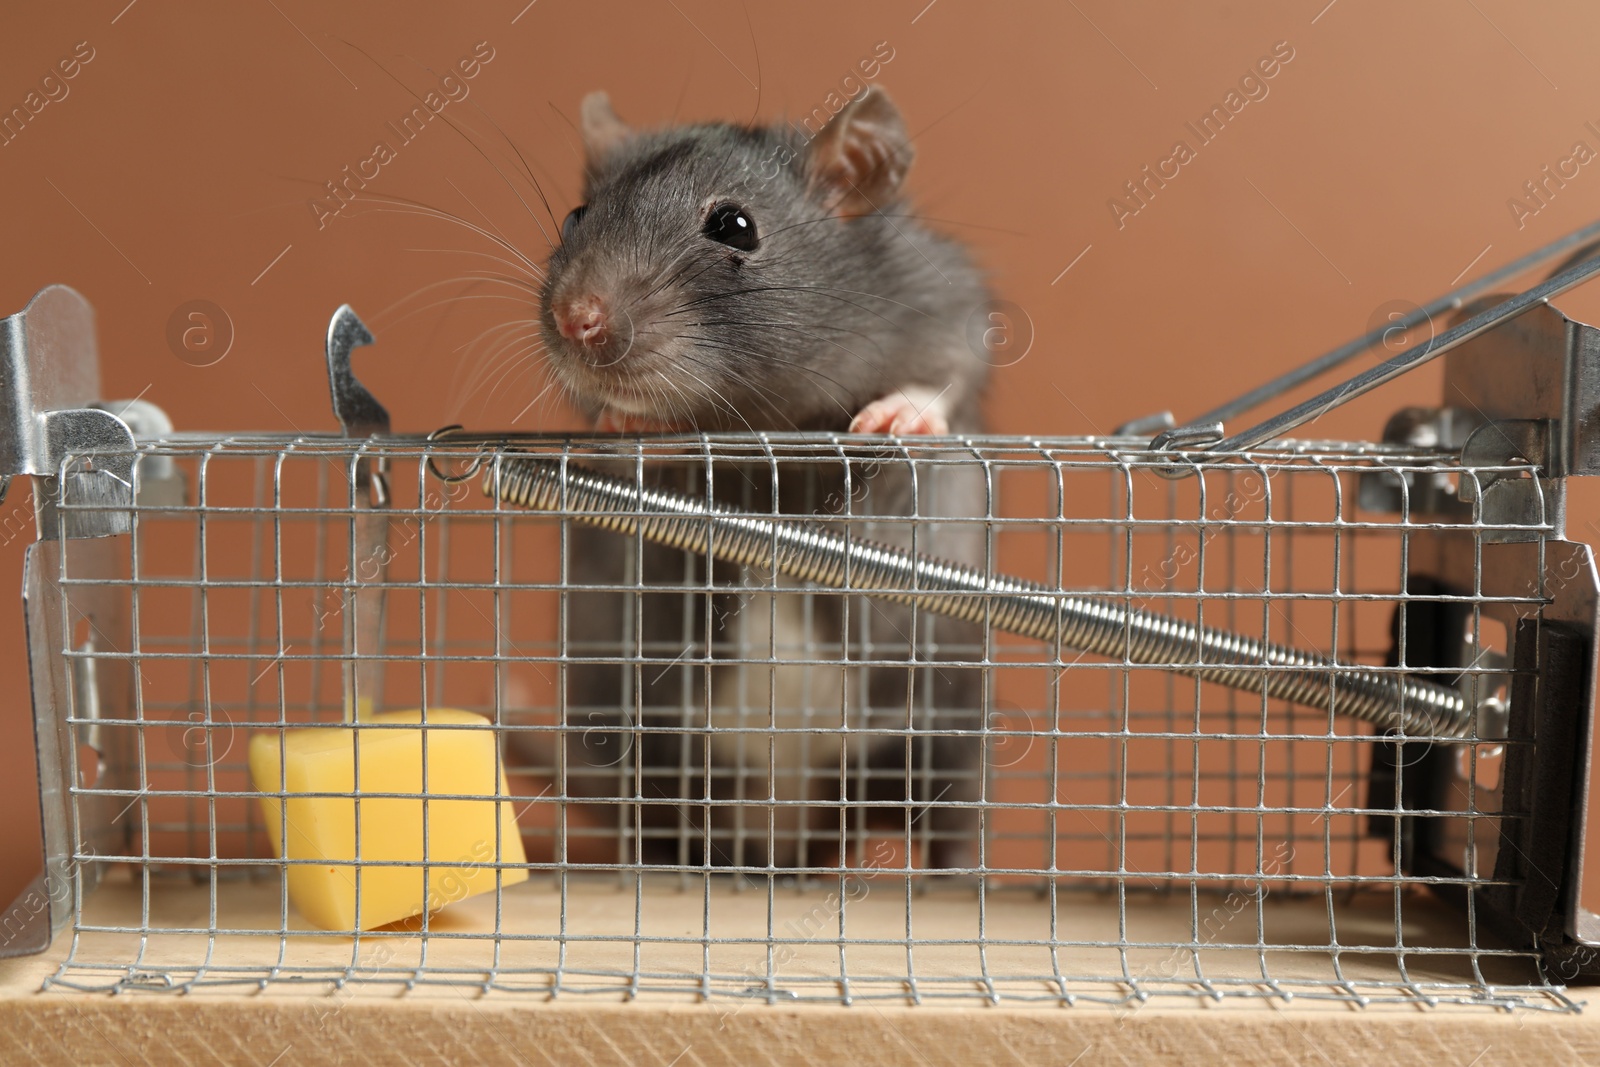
[0, 0, 1600, 907]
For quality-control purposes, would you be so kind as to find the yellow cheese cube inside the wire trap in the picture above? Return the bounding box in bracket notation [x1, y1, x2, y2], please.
[250, 707, 528, 929]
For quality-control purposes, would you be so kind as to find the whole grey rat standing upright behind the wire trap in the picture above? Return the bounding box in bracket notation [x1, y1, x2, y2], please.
[524, 86, 990, 869]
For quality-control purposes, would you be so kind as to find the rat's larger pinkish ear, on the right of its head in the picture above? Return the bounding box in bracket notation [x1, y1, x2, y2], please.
[806, 86, 912, 214]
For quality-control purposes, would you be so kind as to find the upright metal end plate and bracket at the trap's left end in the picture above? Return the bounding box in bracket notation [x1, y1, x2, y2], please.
[0, 285, 136, 957]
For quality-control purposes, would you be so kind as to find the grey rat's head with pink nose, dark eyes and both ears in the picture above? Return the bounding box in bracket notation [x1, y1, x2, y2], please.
[539, 90, 910, 429]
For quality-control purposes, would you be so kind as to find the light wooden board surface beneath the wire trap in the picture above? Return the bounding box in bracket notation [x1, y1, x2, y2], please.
[0, 880, 1600, 1067]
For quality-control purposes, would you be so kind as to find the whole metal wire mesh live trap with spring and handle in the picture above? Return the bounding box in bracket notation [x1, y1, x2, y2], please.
[9, 220, 1600, 1011]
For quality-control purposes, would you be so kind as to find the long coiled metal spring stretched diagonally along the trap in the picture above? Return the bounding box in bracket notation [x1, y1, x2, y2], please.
[483, 458, 1475, 737]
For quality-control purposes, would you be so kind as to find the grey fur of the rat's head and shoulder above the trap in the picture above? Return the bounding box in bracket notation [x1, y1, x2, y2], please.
[541, 95, 989, 432]
